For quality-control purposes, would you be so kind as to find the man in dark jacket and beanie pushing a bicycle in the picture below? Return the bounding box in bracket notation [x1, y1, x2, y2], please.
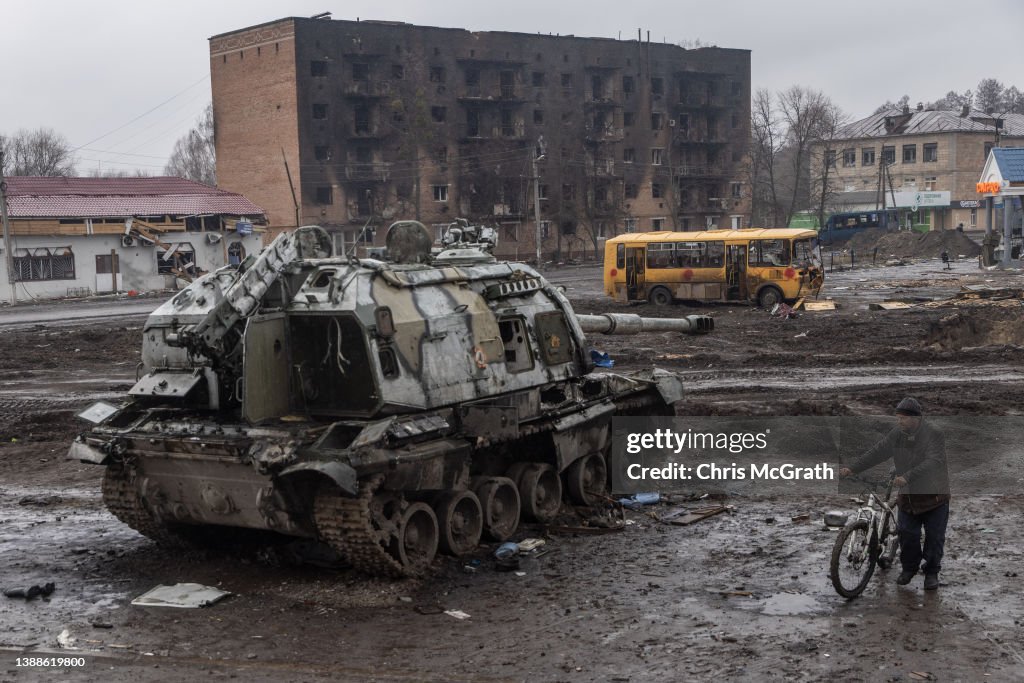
[839, 397, 949, 591]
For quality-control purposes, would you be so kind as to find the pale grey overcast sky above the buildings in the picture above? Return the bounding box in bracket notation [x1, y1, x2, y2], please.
[0, 0, 1024, 174]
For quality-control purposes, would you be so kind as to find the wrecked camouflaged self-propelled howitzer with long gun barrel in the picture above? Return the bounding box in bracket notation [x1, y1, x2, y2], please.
[70, 221, 712, 575]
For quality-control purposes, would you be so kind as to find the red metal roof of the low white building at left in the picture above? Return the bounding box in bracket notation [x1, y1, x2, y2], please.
[7, 176, 263, 218]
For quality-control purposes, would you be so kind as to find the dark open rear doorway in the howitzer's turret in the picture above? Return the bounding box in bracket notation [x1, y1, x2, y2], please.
[290, 315, 377, 415]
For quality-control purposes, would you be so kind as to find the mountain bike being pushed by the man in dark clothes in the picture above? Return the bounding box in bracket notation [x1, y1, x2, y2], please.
[826, 472, 899, 599]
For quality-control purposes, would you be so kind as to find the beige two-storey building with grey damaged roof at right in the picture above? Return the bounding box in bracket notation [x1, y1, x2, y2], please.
[815, 106, 1024, 229]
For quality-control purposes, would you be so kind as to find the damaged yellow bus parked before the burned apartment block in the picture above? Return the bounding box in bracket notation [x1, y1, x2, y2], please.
[604, 228, 824, 308]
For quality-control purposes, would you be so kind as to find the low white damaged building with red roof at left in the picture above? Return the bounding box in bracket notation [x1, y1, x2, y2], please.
[0, 177, 265, 302]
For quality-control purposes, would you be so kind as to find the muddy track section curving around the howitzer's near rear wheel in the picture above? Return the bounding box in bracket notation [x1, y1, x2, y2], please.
[313, 475, 412, 578]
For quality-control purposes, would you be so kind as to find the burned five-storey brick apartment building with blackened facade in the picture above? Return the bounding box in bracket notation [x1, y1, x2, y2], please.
[210, 17, 751, 259]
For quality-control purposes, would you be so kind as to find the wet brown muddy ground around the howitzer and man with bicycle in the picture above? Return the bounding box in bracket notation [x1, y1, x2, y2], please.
[0, 253, 1024, 682]
